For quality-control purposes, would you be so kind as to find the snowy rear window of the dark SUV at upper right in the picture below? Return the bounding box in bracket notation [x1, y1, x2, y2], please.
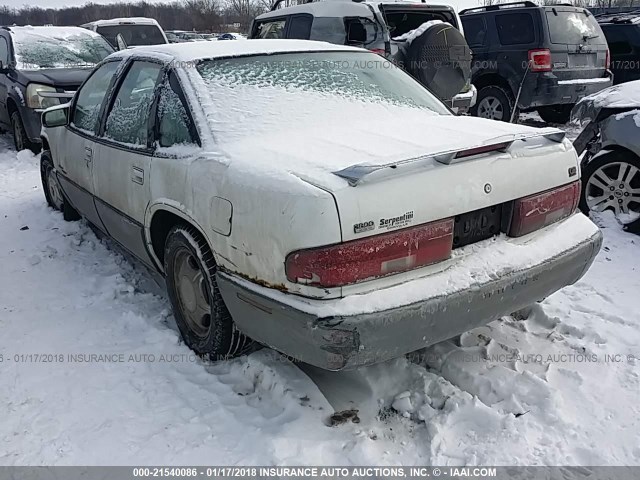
[547, 8, 604, 45]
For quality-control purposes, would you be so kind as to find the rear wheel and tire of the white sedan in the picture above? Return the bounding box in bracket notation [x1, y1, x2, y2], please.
[164, 225, 252, 360]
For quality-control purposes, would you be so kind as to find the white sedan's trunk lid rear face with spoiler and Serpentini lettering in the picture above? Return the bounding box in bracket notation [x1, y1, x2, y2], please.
[310, 117, 578, 246]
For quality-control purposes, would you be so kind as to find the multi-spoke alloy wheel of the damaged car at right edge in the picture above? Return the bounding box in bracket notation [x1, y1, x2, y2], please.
[580, 151, 640, 225]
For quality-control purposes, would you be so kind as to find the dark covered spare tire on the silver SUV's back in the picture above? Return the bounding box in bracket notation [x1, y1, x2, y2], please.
[405, 23, 471, 100]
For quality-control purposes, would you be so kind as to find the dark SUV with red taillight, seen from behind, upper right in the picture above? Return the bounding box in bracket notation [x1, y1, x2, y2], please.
[460, 1, 613, 123]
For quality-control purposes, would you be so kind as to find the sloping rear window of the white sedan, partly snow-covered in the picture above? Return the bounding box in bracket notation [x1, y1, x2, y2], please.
[195, 51, 450, 143]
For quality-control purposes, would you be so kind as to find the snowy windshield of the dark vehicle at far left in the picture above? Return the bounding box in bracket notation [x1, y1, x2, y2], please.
[11, 27, 114, 70]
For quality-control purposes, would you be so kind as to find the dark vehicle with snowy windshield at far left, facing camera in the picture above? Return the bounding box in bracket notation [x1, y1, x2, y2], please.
[0, 27, 114, 152]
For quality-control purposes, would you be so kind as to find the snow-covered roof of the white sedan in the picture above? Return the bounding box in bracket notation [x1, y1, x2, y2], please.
[112, 39, 367, 62]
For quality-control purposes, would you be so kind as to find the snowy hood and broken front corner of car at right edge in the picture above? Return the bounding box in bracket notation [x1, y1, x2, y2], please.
[571, 80, 640, 125]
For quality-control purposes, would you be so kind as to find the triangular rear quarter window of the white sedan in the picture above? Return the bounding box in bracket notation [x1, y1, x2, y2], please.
[158, 72, 198, 147]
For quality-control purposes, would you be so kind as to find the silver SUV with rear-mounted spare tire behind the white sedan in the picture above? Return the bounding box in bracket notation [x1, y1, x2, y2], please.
[249, 0, 476, 113]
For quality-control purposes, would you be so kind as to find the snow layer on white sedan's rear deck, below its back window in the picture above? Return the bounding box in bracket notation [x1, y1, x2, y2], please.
[189, 59, 539, 189]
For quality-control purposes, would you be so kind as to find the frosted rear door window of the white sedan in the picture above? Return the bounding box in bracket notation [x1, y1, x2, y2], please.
[104, 62, 162, 147]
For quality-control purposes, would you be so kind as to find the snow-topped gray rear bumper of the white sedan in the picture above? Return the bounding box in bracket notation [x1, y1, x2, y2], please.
[217, 214, 602, 370]
